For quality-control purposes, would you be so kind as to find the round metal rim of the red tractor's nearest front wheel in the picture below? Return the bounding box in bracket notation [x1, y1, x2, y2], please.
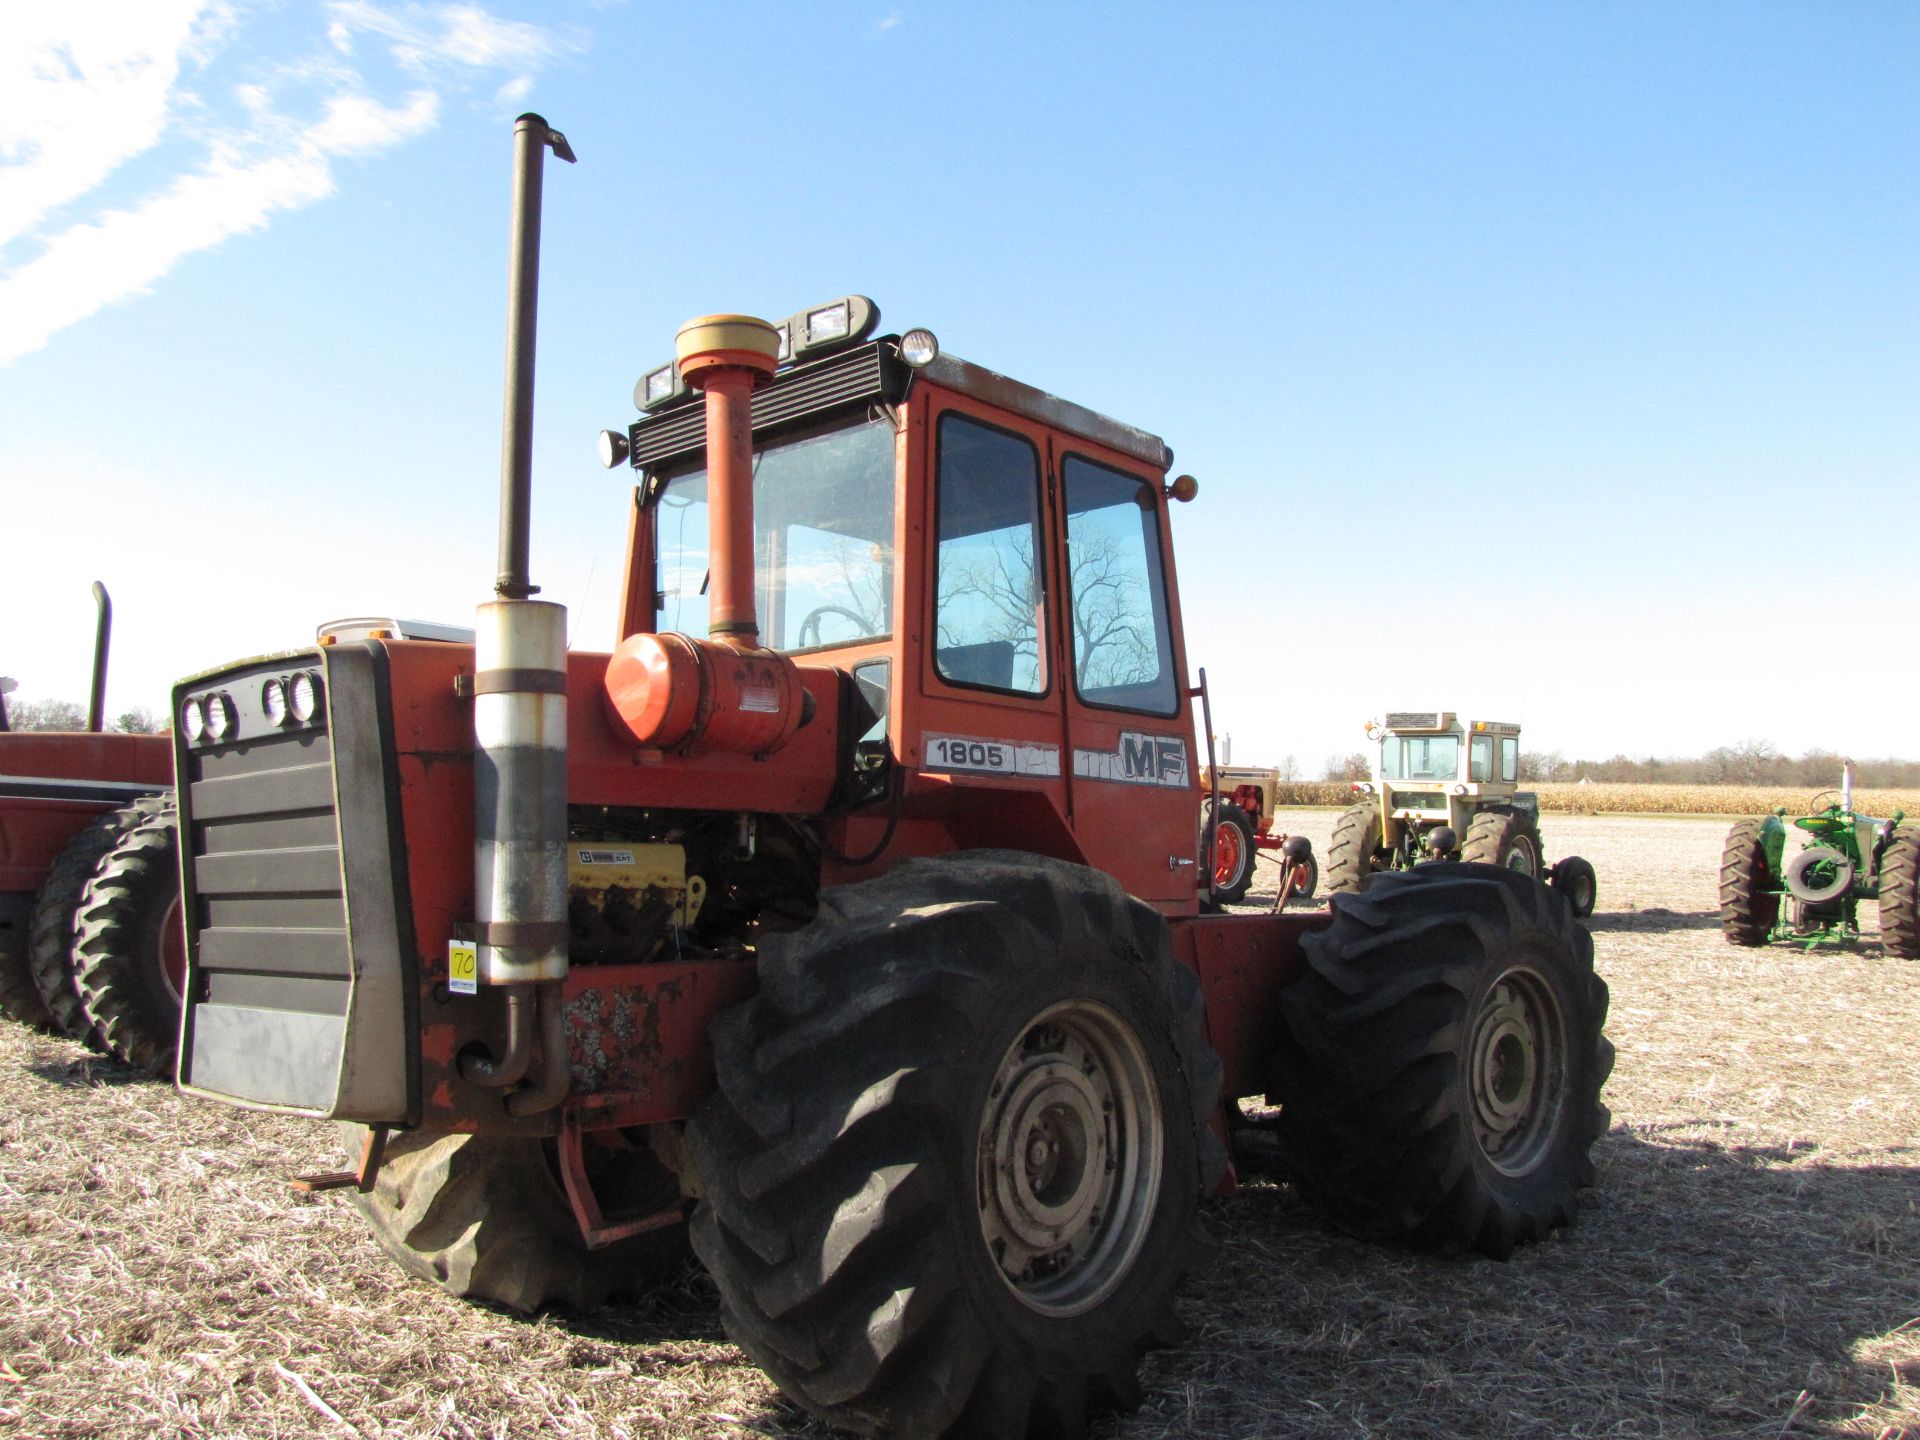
[977, 1000, 1165, 1315]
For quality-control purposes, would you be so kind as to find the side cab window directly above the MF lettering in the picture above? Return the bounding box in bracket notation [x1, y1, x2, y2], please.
[1062, 455, 1179, 714]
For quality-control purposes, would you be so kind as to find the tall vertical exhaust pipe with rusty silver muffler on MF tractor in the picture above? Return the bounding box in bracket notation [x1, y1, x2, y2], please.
[463, 115, 574, 1108]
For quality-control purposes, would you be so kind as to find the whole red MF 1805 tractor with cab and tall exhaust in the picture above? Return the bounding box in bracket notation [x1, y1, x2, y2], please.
[175, 115, 1613, 1438]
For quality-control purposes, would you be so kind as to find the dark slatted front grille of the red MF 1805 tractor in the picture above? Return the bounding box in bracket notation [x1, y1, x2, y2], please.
[175, 641, 419, 1123]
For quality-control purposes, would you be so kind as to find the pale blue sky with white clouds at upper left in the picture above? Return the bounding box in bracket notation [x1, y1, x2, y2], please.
[0, 0, 1920, 770]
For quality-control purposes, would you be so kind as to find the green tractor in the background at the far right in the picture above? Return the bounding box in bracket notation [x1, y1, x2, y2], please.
[1720, 764, 1920, 960]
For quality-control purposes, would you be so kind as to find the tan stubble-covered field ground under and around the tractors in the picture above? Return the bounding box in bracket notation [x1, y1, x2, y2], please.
[0, 810, 1920, 1440]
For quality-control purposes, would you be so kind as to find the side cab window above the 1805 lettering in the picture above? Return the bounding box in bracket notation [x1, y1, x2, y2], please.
[933, 413, 1046, 695]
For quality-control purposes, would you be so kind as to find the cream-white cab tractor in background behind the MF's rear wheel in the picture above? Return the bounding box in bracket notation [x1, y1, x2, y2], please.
[1327, 710, 1596, 920]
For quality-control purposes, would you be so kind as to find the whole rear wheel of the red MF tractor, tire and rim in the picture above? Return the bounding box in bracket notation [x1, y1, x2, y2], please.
[1271, 864, 1613, 1258]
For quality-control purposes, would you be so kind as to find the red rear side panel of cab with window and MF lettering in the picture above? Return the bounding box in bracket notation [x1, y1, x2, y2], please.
[1050, 445, 1198, 912]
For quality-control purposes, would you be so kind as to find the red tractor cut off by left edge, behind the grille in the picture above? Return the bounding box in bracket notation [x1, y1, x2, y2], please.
[0, 582, 186, 1075]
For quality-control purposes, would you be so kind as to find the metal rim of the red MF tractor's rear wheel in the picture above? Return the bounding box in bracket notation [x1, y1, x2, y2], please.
[1467, 968, 1567, 1175]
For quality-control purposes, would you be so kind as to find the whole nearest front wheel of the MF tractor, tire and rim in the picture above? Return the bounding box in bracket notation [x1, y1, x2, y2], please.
[687, 851, 1225, 1440]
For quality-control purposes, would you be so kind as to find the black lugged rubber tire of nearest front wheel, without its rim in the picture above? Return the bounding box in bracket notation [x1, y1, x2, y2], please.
[687, 851, 1227, 1440]
